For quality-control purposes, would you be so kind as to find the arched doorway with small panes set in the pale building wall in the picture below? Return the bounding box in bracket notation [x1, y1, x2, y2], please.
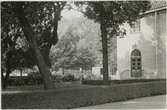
[131, 49, 142, 77]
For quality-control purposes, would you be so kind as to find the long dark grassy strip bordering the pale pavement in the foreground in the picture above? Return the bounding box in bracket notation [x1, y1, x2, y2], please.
[2, 80, 166, 109]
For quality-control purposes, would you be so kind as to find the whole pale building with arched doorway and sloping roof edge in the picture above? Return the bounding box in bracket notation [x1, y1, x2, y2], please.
[112, 1, 167, 79]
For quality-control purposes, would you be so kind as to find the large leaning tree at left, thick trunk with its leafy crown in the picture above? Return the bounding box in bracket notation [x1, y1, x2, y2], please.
[2, 2, 65, 89]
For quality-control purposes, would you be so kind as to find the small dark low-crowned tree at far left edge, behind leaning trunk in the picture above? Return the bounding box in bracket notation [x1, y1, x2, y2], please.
[1, 48, 35, 89]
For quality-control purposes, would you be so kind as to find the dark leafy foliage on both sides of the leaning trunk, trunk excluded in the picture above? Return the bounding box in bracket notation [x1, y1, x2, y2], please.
[1, 2, 66, 71]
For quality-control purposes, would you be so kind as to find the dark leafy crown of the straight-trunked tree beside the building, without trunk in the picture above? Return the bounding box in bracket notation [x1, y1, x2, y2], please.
[76, 1, 151, 36]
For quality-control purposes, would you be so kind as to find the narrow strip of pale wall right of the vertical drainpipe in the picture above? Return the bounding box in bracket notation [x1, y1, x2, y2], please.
[157, 11, 167, 77]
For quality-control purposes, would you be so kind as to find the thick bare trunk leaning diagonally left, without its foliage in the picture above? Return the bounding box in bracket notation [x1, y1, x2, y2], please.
[15, 3, 54, 89]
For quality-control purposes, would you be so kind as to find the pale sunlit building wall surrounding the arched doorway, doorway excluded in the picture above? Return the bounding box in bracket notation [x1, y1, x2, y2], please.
[117, 10, 167, 79]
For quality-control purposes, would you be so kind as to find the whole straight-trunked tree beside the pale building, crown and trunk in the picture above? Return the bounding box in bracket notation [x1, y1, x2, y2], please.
[76, 1, 150, 82]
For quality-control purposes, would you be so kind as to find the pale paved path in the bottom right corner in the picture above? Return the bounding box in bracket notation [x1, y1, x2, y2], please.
[81, 95, 167, 109]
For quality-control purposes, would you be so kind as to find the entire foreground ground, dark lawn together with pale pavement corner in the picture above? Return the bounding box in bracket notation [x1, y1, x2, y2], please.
[2, 81, 166, 109]
